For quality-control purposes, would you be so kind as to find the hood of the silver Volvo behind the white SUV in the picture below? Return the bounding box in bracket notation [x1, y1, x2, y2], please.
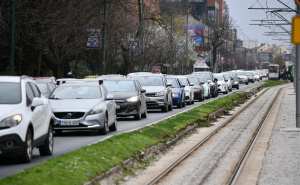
[50, 99, 101, 110]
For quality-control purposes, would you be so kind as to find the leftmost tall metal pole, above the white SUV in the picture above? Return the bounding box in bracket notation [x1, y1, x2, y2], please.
[9, 0, 15, 76]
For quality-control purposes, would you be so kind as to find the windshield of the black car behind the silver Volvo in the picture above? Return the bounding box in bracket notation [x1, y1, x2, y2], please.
[103, 80, 136, 92]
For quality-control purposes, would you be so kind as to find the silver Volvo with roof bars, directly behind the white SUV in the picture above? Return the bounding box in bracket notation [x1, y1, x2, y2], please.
[49, 80, 117, 135]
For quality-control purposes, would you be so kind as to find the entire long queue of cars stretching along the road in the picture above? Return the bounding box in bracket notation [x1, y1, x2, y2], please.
[0, 71, 263, 162]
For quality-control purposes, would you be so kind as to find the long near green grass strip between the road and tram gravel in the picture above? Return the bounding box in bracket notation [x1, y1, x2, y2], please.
[0, 93, 246, 185]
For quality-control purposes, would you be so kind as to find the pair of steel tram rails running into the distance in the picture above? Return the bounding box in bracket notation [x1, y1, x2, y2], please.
[146, 87, 283, 185]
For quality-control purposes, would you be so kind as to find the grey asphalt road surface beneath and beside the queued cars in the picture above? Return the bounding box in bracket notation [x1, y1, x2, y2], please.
[0, 82, 257, 179]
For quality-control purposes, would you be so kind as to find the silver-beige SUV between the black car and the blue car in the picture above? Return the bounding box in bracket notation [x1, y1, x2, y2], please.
[128, 73, 173, 112]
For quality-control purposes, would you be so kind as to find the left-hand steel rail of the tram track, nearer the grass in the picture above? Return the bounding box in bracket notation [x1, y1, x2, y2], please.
[145, 89, 269, 185]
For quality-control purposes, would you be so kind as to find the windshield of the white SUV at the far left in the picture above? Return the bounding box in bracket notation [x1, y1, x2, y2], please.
[0, 82, 21, 104]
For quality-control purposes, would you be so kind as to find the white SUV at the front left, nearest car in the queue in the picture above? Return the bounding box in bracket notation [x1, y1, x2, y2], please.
[0, 76, 54, 162]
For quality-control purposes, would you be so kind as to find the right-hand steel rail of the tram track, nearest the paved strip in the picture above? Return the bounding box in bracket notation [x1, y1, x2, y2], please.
[228, 87, 284, 185]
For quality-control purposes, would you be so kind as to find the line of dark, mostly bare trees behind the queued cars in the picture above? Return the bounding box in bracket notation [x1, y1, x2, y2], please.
[0, 0, 234, 78]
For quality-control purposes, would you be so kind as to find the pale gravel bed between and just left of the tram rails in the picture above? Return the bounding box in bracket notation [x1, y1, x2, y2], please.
[120, 84, 286, 184]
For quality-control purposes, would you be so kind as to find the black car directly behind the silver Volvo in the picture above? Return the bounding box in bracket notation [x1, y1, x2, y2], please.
[103, 78, 147, 120]
